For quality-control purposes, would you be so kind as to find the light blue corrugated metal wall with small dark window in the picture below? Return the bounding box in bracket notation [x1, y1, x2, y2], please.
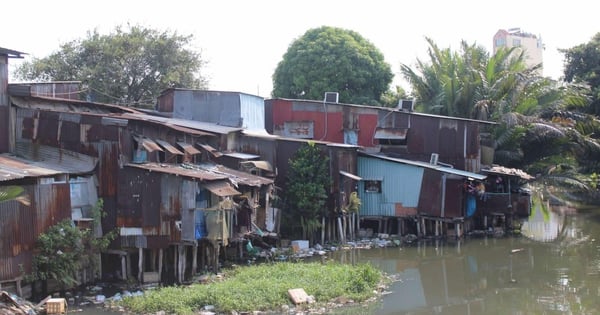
[357, 156, 423, 216]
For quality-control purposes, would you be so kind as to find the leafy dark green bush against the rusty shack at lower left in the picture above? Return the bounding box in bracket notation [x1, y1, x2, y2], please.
[25, 199, 116, 289]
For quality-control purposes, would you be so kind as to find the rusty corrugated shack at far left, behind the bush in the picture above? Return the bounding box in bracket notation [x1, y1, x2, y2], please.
[0, 145, 101, 297]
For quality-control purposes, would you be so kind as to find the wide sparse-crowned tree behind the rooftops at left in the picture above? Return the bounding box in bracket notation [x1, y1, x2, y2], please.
[14, 26, 207, 107]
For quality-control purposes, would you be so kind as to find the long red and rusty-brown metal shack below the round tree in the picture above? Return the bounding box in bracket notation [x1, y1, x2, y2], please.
[265, 97, 492, 173]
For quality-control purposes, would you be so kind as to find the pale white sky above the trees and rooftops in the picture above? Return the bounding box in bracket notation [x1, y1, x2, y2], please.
[0, 0, 600, 98]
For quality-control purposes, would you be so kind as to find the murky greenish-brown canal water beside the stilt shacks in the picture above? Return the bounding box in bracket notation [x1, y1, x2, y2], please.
[80, 207, 600, 315]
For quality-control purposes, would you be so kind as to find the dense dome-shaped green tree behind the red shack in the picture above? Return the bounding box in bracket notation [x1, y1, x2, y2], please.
[272, 26, 393, 105]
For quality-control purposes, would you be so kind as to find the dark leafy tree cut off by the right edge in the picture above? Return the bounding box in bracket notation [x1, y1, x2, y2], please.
[559, 33, 600, 115]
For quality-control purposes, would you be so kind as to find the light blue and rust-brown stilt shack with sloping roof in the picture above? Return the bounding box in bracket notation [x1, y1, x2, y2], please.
[358, 152, 486, 237]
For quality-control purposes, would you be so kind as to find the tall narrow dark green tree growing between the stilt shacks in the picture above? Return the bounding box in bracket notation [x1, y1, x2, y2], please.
[283, 142, 331, 241]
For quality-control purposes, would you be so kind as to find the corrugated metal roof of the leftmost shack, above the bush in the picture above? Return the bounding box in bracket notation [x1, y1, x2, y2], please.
[0, 151, 96, 181]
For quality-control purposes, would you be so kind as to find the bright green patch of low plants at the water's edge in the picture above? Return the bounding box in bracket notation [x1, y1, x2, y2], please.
[121, 262, 384, 314]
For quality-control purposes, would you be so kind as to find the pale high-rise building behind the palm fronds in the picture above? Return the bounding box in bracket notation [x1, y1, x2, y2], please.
[494, 28, 544, 75]
